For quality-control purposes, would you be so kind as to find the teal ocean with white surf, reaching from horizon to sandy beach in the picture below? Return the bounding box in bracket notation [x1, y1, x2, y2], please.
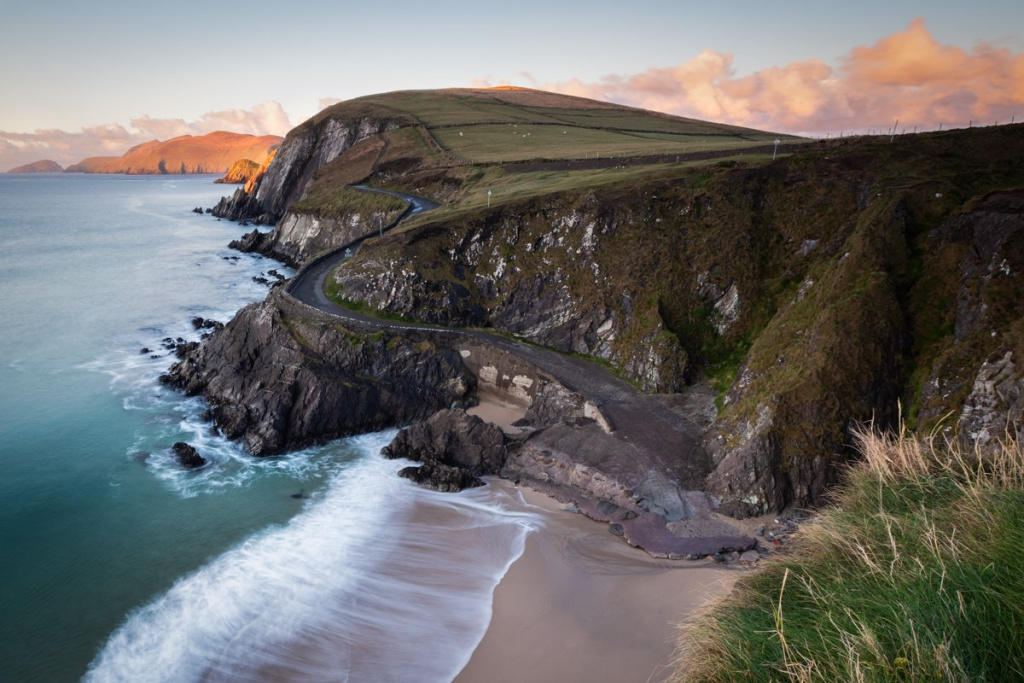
[0, 174, 543, 683]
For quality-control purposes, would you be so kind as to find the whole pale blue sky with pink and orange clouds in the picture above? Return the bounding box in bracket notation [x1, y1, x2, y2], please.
[0, 0, 1024, 171]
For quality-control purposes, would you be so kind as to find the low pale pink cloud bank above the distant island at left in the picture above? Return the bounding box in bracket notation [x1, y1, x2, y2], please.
[0, 100, 292, 171]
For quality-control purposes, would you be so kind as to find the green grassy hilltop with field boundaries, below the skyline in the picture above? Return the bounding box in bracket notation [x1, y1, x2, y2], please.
[292, 88, 802, 206]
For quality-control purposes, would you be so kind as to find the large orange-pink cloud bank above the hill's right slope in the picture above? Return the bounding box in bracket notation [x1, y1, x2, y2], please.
[491, 18, 1024, 133]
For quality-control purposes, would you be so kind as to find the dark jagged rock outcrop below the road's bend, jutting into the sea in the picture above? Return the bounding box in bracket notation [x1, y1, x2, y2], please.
[164, 294, 473, 456]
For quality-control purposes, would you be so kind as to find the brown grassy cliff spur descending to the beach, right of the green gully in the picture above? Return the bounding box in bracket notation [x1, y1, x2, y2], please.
[707, 197, 908, 515]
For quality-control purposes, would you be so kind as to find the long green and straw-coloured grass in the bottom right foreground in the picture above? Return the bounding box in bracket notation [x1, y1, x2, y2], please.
[675, 433, 1024, 683]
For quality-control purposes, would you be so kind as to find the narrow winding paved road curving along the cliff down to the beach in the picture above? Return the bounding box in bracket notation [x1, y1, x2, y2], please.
[285, 187, 710, 490]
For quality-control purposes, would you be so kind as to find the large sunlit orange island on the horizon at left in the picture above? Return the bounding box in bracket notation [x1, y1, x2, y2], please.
[56, 131, 283, 175]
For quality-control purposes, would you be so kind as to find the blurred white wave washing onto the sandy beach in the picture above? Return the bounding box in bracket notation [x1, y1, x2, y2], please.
[85, 434, 539, 683]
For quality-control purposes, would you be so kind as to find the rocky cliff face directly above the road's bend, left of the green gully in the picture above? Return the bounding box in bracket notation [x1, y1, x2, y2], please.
[335, 194, 687, 391]
